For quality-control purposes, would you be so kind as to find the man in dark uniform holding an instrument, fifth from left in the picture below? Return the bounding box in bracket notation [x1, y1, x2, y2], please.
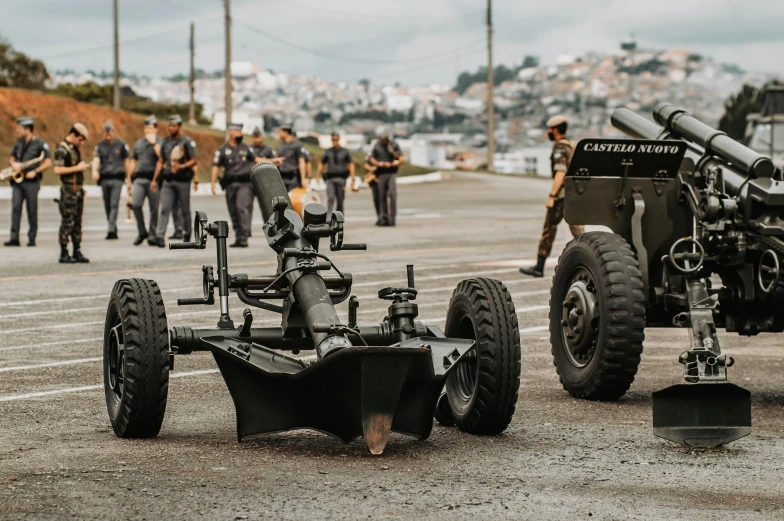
[150, 115, 196, 248]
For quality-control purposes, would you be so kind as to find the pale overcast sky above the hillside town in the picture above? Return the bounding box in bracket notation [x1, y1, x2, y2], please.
[6, 0, 784, 85]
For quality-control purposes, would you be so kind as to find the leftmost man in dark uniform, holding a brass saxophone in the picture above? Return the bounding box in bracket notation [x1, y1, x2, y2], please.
[3, 116, 52, 246]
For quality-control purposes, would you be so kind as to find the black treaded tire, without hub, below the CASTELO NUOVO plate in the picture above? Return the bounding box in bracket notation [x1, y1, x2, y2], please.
[550, 232, 645, 401]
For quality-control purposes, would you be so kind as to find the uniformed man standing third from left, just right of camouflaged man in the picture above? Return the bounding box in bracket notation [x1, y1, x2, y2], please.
[93, 119, 130, 241]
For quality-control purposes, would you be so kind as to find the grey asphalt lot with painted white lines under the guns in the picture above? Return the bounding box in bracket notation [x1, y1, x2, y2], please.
[0, 174, 784, 520]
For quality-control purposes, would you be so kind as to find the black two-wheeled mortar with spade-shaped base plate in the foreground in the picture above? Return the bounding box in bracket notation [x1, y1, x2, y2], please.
[103, 163, 520, 454]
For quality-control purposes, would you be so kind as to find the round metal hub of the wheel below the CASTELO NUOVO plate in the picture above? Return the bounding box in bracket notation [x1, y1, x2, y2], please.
[561, 268, 599, 367]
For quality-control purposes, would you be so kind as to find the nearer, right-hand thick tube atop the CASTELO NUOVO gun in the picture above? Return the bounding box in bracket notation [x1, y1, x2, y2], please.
[653, 102, 776, 179]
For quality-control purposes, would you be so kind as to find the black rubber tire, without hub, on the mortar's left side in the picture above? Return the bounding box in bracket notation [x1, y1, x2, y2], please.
[103, 279, 169, 438]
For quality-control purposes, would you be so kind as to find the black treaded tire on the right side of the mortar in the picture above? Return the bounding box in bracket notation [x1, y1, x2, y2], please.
[444, 278, 520, 435]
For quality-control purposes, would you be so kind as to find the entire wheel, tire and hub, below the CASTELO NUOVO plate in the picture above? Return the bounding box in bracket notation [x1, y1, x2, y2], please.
[550, 232, 645, 400]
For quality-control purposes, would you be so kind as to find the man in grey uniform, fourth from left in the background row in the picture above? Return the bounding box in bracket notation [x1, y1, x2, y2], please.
[126, 116, 163, 246]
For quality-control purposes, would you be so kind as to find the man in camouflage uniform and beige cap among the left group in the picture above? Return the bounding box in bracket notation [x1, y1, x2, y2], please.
[54, 123, 90, 264]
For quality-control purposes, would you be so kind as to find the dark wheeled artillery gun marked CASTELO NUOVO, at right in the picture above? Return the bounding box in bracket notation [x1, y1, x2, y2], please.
[550, 103, 784, 447]
